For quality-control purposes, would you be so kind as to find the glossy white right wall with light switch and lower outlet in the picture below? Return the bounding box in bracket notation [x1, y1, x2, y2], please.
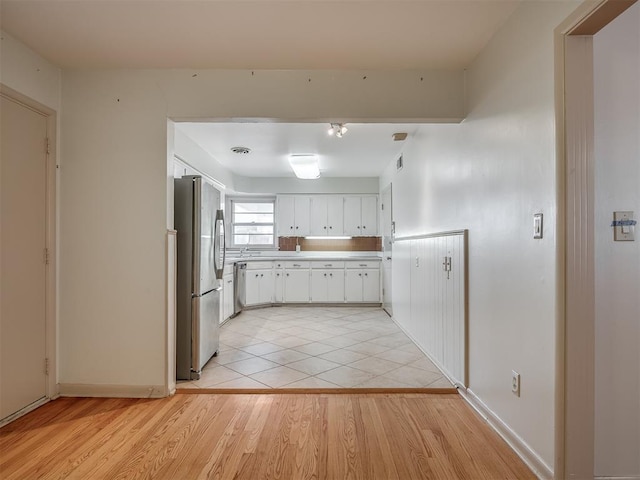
[380, 2, 577, 474]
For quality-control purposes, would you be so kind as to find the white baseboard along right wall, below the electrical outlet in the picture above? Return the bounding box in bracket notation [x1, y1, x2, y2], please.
[459, 388, 553, 480]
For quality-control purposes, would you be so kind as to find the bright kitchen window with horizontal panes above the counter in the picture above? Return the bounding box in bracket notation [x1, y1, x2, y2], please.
[228, 197, 276, 249]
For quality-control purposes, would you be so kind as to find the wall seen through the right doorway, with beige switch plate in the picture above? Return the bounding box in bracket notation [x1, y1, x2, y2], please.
[593, 4, 640, 478]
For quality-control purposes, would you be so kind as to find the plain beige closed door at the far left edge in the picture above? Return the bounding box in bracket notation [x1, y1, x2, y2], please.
[0, 97, 47, 419]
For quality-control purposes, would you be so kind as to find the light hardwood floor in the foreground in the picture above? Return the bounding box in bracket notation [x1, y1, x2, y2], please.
[0, 393, 535, 480]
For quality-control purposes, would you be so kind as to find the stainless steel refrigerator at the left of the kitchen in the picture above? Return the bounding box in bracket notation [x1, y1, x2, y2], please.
[174, 175, 225, 380]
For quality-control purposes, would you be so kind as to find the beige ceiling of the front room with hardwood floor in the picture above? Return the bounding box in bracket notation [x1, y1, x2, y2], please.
[0, 0, 520, 70]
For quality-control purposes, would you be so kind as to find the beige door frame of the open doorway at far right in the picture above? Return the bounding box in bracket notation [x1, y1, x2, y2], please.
[554, 0, 637, 479]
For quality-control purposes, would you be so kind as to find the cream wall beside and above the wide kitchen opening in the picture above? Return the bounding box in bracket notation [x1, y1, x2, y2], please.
[60, 66, 463, 393]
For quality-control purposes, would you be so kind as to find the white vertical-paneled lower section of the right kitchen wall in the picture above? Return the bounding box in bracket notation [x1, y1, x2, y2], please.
[392, 230, 468, 386]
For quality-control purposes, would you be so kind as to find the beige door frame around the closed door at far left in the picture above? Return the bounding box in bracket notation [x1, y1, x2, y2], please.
[0, 83, 59, 423]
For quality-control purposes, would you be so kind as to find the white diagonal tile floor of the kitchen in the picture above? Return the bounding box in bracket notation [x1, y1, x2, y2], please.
[178, 306, 452, 389]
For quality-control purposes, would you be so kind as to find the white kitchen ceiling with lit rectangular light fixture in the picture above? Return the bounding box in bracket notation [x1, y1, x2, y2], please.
[176, 123, 419, 177]
